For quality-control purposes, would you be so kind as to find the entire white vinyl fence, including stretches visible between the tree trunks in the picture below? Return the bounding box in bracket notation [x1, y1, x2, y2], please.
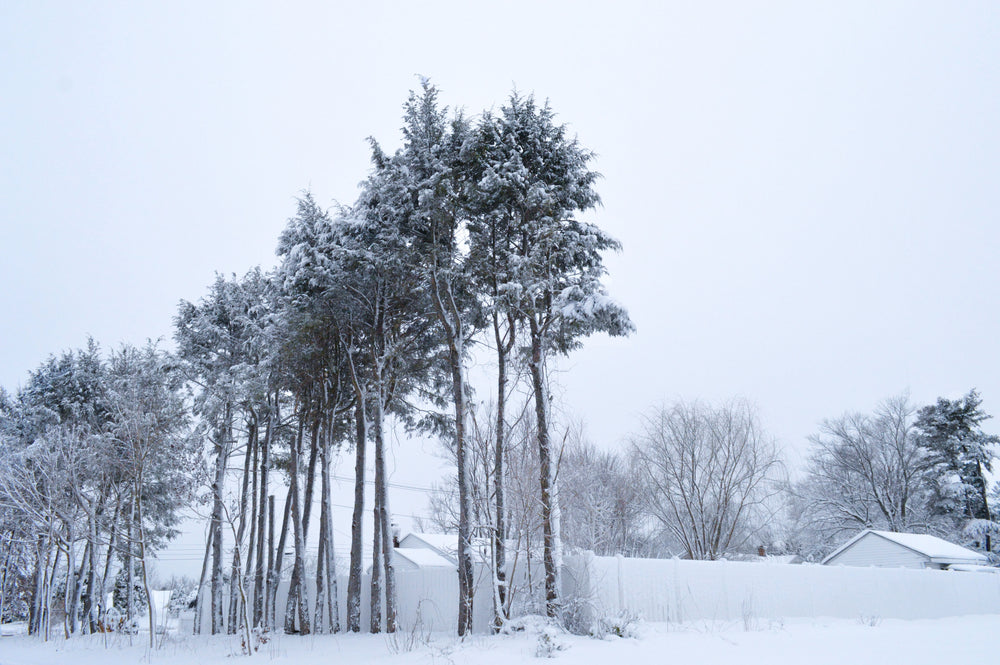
[188, 552, 1000, 633]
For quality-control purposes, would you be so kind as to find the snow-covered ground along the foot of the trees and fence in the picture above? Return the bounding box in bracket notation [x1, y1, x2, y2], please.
[0, 615, 1000, 665]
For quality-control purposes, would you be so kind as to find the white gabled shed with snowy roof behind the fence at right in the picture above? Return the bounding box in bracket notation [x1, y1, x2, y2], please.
[823, 529, 988, 570]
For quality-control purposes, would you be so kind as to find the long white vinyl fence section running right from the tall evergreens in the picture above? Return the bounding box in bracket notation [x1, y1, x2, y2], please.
[563, 552, 1000, 621]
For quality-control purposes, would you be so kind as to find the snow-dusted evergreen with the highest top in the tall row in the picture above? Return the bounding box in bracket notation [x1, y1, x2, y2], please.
[365, 79, 475, 635]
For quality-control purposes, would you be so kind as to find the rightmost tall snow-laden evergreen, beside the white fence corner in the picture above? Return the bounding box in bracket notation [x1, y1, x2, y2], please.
[477, 93, 633, 616]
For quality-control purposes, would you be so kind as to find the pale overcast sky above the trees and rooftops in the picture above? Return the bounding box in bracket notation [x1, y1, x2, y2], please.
[0, 0, 1000, 482]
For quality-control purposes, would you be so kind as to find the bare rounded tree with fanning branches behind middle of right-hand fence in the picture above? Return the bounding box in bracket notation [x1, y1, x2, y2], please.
[633, 401, 782, 559]
